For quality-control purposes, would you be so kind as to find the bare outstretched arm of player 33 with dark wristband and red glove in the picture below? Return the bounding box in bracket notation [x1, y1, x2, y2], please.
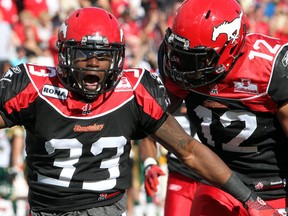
[151, 115, 280, 216]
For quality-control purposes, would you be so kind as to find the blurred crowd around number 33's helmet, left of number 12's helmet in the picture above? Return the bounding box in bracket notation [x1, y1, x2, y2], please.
[0, 0, 182, 75]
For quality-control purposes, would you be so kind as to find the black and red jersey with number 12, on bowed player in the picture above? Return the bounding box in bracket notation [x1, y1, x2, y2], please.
[159, 34, 288, 199]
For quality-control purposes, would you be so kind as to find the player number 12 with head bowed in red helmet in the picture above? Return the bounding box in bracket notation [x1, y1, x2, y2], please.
[148, 0, 288, 216]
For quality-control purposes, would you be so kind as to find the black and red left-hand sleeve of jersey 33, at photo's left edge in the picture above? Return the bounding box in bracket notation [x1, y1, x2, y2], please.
[0, 64, 30, 127]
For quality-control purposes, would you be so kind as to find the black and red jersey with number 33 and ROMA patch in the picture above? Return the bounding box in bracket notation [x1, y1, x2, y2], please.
[0, 64, 167, 212]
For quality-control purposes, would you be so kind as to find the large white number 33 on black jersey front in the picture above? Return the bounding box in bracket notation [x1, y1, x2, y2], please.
[38, 136, 127, 191]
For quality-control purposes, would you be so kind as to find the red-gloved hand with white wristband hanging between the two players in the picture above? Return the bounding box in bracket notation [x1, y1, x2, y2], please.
[144, 159, 165, 196]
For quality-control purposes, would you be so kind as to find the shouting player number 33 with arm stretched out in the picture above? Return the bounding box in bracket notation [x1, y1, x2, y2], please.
[0, 7, 275, 216]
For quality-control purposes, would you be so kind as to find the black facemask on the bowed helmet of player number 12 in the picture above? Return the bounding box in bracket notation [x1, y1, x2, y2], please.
[164, 28, 224, 90]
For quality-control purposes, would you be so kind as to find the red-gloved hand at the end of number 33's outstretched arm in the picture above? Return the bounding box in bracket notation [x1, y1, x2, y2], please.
[245, 196, 286, 216]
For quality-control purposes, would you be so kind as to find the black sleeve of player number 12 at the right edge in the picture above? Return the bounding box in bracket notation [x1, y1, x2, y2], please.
[268, 44, 288, 106]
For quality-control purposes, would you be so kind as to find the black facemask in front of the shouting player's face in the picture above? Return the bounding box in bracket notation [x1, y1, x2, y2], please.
[58, 41, 124, 100]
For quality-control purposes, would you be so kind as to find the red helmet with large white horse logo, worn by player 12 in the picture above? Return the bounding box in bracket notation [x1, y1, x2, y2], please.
[164, 0, 246, 90]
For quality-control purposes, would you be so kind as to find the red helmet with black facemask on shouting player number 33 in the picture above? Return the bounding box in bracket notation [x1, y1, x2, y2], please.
[57, 7, 125, 99]
